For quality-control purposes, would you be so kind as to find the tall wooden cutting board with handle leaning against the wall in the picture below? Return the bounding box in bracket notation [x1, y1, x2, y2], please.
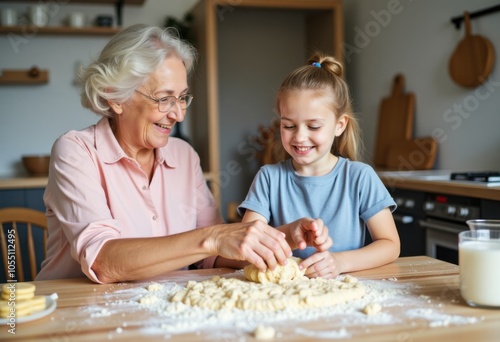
[374, 74, 415, 168]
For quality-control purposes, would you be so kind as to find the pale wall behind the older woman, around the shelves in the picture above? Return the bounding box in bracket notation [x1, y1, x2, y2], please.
[0, 0, 196, 177]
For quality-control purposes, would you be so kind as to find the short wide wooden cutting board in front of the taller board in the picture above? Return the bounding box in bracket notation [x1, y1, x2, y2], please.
[386, 137, 437, 171]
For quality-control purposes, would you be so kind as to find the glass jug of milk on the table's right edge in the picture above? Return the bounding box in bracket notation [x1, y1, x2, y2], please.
[458, 220, 500, 309]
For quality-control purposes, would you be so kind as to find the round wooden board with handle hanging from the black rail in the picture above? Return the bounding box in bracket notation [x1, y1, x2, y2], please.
[448, 12, 495, 88]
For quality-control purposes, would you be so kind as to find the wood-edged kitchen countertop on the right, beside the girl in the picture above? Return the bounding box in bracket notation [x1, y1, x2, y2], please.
[377, 170, 500, 201]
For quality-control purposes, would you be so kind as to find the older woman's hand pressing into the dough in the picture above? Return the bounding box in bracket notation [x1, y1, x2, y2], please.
[211, 220, 292, 271]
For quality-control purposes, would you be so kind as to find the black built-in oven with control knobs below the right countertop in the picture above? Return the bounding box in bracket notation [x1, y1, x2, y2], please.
[420, 194, 481, 265]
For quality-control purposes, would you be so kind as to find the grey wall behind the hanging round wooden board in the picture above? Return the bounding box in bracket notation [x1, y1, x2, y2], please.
[344, 0, 500, 170]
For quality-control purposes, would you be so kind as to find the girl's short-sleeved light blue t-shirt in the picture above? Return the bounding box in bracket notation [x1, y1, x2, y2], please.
[238, 157, 396, 259]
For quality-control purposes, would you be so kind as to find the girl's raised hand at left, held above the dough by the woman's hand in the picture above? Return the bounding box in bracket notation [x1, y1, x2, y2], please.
[288, 217, 333, 252]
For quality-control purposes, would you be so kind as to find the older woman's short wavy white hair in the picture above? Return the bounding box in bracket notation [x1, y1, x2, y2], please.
[78, 24, 196, 117]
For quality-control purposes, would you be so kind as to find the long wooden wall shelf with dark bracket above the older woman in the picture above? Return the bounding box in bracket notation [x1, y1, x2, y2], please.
[0, 0, 145, 35]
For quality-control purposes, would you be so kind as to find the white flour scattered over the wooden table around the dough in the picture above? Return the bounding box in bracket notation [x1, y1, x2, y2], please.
[80, 270, 482, 341]
